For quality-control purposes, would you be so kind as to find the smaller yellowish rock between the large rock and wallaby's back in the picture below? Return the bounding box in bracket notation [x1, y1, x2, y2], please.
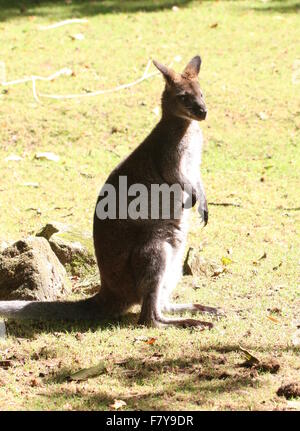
[37, 222, 96, 275]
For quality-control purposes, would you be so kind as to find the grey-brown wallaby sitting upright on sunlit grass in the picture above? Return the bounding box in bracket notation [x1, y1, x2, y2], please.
[0, 56, 218, 328]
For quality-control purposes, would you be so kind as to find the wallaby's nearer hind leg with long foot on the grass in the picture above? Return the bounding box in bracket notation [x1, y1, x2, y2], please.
[137, 243, 213, 328]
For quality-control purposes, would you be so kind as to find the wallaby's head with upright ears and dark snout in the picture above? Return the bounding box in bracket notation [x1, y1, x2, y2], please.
[153, 55, 207, 121]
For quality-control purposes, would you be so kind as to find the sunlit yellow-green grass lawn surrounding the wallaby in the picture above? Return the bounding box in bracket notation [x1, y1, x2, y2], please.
[0, 0, 300, 410]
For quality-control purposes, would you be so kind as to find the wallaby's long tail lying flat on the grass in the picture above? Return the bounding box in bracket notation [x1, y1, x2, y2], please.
[0, 293, 112, 320]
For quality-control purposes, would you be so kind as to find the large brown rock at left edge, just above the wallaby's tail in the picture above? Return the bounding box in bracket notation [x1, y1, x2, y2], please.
[0, 237, 69, 301]
